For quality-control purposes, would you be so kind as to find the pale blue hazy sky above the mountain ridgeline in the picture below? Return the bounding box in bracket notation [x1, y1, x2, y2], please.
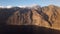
[0, 0, 60, 6]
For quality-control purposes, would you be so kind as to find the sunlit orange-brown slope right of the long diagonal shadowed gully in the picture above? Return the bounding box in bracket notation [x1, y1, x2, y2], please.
[42, 5, 60, 29]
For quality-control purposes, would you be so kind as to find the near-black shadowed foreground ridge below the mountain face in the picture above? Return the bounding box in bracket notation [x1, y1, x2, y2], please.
[0, 25, 60, 34]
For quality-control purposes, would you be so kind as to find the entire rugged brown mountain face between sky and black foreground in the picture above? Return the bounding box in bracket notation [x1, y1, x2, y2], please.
[0, 5, 60, 29]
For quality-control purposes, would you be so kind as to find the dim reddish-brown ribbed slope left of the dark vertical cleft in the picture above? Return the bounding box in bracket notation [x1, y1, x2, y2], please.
[7, 8, 31, 25]
